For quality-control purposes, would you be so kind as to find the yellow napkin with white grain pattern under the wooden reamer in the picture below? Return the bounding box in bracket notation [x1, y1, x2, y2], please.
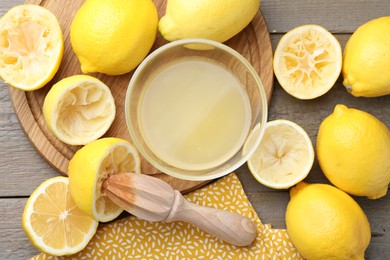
[32, 173, 302, 259]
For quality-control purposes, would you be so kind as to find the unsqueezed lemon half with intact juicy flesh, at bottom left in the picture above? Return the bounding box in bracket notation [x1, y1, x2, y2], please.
[22, 176, 99, 256]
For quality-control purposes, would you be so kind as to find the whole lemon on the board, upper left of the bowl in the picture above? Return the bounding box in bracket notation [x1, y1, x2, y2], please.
[70, 0, 158, 75]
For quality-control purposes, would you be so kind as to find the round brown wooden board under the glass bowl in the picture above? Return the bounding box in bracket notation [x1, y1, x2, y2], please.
[10, 0, 273, 193]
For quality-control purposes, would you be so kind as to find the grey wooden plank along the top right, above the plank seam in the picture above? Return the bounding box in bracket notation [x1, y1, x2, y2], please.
[260, 0, 390, 33]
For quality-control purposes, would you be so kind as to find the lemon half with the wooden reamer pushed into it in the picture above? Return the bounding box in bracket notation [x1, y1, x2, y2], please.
[68, 137, 141, 222]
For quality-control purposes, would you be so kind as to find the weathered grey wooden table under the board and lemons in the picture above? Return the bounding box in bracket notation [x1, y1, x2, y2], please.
[0, 0, 390, 259]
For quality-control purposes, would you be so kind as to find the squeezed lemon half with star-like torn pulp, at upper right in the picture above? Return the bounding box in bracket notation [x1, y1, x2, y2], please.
[273, 25, 342, 99]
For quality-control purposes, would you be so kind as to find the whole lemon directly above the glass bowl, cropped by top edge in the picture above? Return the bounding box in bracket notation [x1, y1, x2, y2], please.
[158, 0, 260, 42]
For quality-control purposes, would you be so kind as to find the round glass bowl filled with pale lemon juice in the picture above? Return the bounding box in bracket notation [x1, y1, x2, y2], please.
[125, 39, 267, 180]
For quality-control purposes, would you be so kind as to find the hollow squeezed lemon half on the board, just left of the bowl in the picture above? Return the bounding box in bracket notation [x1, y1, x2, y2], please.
[42, 75, 115, 145]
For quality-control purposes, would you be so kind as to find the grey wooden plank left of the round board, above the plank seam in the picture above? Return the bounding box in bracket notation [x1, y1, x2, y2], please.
[0, 86, 58, 197]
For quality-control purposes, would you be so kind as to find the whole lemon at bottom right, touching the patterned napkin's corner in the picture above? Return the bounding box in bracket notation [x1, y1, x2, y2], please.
[286, 182, 371, 260]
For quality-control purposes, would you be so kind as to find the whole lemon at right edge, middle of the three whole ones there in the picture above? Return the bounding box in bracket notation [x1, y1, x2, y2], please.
[316, 105, 390, 199]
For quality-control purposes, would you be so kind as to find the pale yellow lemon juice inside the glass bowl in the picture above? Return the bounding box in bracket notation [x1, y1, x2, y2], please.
[139, 58, 251, 170]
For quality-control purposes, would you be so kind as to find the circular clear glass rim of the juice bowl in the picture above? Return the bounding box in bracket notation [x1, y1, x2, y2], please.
[125, 38, 268, 181]
